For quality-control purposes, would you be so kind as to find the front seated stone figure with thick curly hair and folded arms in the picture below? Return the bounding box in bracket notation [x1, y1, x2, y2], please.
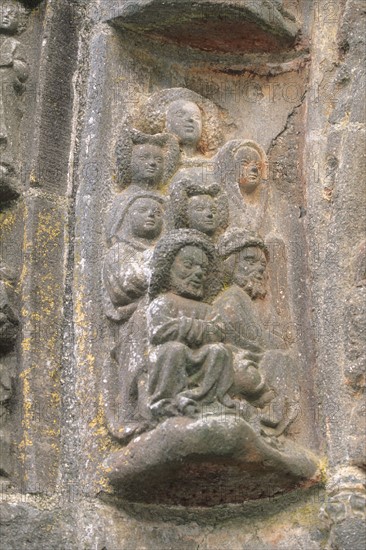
[147, 229, 234, 417]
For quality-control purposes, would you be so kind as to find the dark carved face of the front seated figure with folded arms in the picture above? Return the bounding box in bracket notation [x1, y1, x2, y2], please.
[170, 246, 209, 300]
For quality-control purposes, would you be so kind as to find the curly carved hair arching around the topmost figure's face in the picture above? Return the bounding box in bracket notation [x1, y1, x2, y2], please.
[141, 88, 222, 154]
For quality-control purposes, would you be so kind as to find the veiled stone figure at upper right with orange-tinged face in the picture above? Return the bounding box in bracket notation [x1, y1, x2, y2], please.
[215, 140, 268, 231]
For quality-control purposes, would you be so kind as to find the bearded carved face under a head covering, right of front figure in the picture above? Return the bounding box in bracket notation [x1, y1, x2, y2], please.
[233, 246, 267, 299]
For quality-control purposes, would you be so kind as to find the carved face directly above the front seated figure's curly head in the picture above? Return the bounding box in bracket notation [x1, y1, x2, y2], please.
[187, 195, 219, 235]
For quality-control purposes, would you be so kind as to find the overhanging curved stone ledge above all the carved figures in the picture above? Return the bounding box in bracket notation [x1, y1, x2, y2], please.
[103, 0, 298, 52]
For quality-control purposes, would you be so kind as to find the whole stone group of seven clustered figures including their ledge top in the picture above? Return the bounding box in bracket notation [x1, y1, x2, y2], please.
[103, 88, 317, 504]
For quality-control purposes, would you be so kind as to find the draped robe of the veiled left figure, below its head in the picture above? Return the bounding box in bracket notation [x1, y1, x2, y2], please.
[103, 241, 152, 432]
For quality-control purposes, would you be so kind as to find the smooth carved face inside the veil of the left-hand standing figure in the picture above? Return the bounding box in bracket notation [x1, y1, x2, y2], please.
[128, 198, 163, 239]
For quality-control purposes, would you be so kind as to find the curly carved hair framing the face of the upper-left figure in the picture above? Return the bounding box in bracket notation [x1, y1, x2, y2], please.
[116, 126, 179, 189]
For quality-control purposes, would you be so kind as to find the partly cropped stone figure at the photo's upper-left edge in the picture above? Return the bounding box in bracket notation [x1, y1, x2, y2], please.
[0, 0, 29, 200]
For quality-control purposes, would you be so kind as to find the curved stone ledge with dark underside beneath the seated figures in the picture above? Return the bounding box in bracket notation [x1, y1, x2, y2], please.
[104, 414, 318, 506]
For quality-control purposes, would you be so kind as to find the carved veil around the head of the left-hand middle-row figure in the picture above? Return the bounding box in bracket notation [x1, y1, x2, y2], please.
[106, 191, 165, 246]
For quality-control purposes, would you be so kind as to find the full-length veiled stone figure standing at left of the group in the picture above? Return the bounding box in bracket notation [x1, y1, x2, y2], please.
[103, 190, 164, 439]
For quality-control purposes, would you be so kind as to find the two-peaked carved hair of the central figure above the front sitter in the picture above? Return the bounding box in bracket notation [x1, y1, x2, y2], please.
[170, 169, 229, 235]
